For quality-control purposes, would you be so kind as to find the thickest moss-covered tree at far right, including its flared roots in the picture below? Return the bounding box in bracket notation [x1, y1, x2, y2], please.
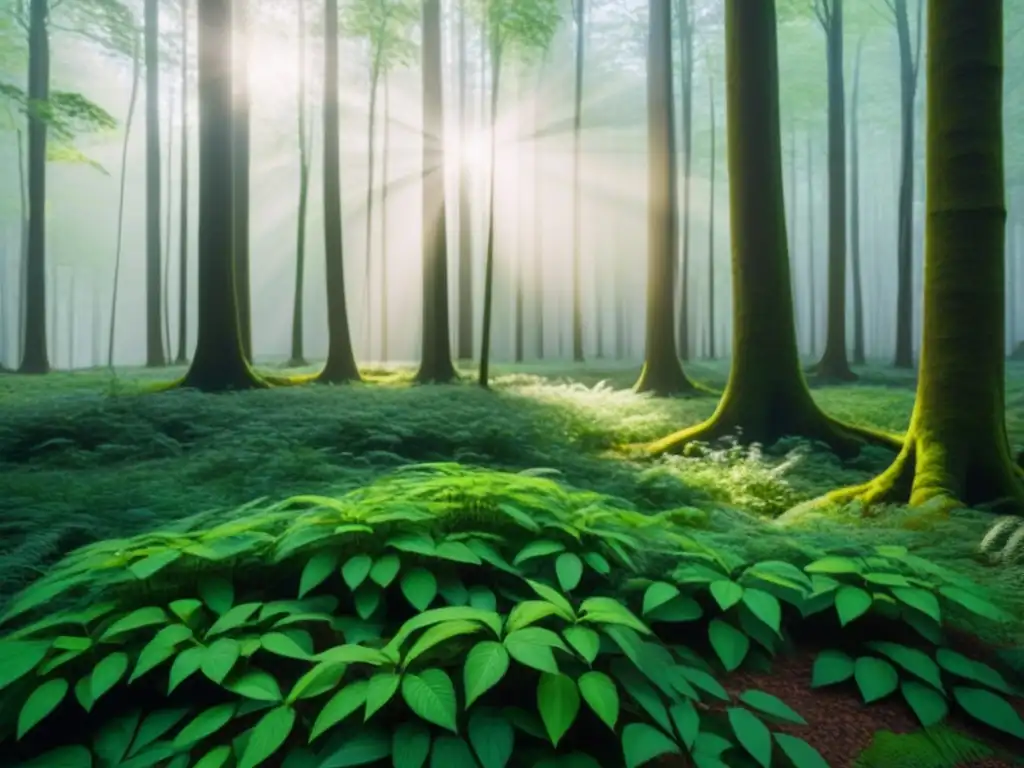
[826, 0, 1024, 513]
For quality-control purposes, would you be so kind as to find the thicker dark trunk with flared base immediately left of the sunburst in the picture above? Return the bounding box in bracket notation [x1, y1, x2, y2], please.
[416, 0, 457, 383]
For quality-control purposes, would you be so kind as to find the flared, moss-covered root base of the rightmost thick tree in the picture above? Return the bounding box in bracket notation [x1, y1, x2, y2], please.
[810, 428, 1024, 515]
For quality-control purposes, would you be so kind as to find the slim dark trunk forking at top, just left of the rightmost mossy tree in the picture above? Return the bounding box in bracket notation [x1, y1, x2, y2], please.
[893, 0, 925, 368]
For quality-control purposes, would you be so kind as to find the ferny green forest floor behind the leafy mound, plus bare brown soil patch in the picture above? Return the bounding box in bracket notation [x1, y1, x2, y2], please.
[0, 361, 1024, 768]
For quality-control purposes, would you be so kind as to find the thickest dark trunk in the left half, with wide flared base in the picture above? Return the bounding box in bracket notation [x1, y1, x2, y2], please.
[181, 0, 266, 392]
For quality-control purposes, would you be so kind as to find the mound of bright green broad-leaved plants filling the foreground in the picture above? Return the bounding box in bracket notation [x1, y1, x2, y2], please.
[0, 464, 1024, 768]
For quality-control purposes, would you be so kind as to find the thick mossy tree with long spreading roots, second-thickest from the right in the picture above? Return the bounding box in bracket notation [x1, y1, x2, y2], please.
[648, 0, 898, 456]
